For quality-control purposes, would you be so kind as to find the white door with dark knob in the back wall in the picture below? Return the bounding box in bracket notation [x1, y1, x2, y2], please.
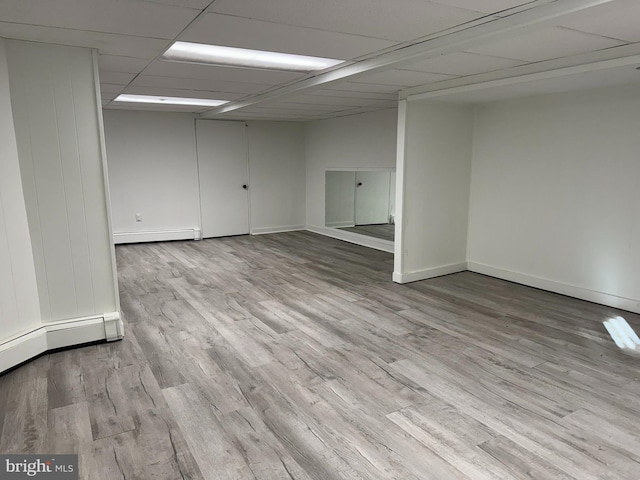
[196, 120, 249, 238]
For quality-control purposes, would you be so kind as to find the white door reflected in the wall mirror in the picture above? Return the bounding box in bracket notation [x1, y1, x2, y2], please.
[356, 172, 389, 225]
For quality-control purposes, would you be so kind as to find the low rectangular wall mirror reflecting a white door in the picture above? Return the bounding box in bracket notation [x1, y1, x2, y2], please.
[325, 168, 396, 241]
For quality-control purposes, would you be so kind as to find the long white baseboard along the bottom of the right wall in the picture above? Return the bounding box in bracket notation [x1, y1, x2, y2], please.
[467, 262, 640, 313]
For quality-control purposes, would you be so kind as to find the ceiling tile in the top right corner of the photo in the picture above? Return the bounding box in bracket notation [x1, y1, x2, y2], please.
[562, 0, 640, 42]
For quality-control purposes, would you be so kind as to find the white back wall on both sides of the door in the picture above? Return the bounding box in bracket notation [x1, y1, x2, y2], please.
[104, 110, 305, 242]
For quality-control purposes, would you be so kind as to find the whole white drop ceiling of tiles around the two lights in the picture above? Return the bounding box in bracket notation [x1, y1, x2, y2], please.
[0, 0, 640, 120]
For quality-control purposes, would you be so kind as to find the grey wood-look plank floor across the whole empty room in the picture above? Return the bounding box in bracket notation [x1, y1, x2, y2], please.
[0, 232, 640, 480]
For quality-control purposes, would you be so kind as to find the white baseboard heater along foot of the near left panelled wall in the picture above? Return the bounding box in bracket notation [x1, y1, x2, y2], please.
[0, 312, 124, 373]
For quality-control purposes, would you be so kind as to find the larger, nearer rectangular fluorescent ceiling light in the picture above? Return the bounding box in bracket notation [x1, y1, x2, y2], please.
[162, 42, 344, 72]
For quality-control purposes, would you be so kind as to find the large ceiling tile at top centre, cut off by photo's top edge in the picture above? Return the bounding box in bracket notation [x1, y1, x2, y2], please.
[211, 0, 482, 41]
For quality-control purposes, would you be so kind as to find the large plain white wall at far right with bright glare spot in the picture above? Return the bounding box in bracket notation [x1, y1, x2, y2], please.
[469, 86, 640, 311]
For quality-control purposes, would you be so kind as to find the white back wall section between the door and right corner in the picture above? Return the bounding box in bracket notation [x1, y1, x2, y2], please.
[248, 122, 306, 233]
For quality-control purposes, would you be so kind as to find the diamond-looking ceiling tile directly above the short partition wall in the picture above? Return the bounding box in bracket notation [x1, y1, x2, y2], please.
[406, 52, 526, 76]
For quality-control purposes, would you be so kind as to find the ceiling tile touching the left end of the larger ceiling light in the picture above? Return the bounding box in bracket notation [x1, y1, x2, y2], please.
[0, 22, 169, 59]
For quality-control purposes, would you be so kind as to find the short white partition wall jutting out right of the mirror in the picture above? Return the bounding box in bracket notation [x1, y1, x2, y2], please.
[394, 102, 473, 282]
